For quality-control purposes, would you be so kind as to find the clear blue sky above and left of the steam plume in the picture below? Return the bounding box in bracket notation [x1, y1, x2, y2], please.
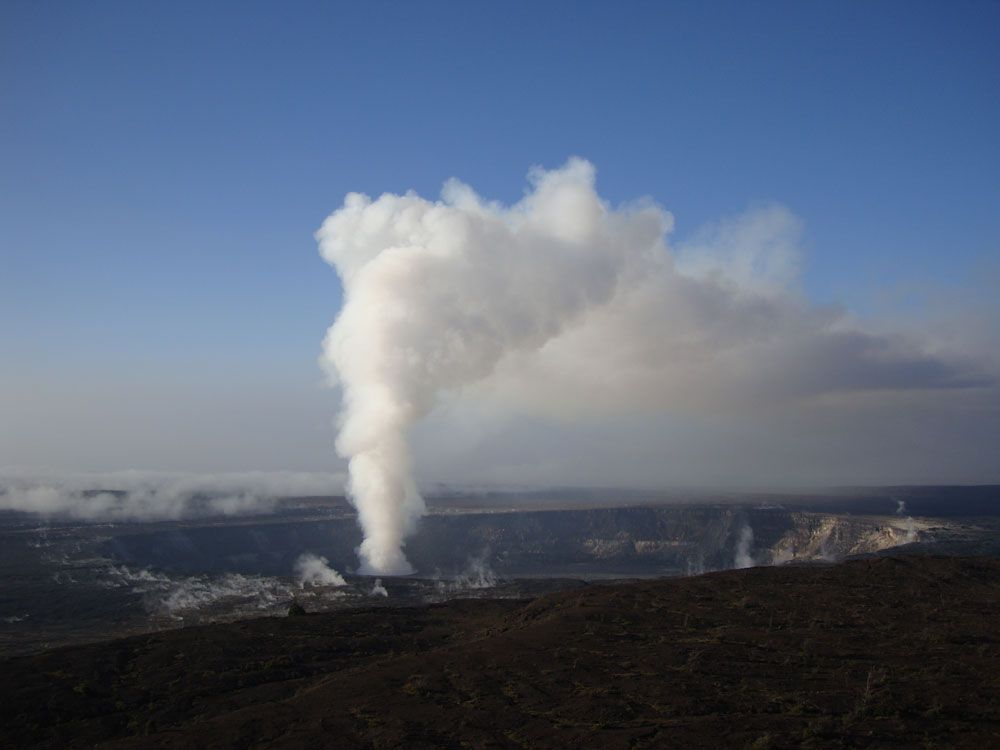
[0, 0, 1000, 482]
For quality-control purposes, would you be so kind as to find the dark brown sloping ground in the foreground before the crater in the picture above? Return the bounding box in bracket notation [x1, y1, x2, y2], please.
[0, 557, 1000, 748]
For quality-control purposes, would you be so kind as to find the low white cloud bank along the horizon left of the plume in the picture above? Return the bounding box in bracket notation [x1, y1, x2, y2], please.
[0, 469, 344, 521]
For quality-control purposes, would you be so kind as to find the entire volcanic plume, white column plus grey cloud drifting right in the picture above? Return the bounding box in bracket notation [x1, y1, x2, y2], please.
[317, 159, 997, 573]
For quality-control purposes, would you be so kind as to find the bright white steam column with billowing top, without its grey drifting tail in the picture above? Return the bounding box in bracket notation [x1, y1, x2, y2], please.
[317, 159, 672, 573]
